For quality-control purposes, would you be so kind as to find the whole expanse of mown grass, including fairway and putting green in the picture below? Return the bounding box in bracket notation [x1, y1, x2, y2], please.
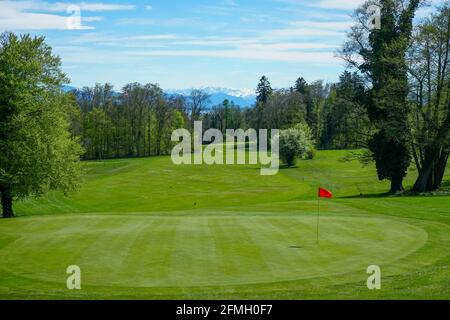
[0, 151, 450, 299]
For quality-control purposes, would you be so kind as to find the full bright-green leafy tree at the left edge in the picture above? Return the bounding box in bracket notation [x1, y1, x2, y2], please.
[0, 33, 82, 217]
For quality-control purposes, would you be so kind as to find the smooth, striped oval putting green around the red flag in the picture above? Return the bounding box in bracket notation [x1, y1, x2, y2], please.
[0, 213, 428, 287]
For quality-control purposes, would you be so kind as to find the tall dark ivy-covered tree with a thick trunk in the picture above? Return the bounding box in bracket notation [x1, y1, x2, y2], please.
[342, 0, 420, 192]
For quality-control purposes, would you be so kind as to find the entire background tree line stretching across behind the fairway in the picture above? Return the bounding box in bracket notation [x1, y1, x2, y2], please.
[68, 72, 368, 160]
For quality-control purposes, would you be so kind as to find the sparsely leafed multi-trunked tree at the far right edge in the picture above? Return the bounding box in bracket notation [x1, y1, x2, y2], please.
[408, 3, 450, 192]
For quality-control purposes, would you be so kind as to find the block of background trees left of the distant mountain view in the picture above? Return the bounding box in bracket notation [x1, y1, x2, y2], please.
[69, 83, 187, 160]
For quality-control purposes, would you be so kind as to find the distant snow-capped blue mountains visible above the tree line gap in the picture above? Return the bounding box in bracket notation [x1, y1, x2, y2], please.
[165, 87, 256, 107]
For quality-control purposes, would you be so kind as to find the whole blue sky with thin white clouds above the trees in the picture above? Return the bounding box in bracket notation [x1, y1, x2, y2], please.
[0, 0, 442, 89]
